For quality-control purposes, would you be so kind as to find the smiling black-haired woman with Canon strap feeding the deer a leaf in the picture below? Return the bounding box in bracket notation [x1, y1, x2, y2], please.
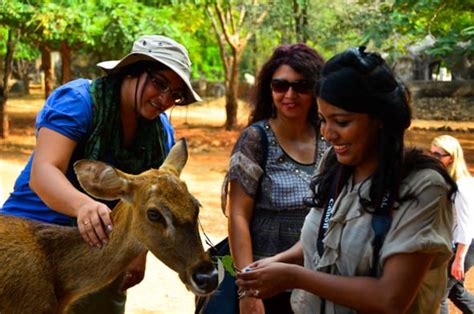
[237, 47, 456, 313]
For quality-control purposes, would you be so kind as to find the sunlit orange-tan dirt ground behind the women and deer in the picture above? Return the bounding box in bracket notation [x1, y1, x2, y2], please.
[0, 89, 474, 314]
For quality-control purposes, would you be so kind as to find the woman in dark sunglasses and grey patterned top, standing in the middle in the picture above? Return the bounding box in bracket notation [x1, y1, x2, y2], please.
[227, 44, 327, 313]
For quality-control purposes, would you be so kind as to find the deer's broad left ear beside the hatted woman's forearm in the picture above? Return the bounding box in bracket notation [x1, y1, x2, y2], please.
[74, 159, 131, 200]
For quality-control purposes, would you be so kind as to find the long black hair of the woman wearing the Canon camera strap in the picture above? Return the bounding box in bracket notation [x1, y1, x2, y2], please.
[311, 47, 456, 211]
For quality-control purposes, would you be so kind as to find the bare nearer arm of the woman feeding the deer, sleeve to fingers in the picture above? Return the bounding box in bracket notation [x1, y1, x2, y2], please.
[237, 253, 434, 313]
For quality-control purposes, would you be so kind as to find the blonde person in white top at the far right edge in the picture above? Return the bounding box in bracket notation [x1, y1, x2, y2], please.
[430, 135, 474, 314]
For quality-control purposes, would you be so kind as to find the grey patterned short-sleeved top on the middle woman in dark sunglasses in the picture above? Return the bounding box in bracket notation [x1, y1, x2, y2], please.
[228, 120, 328, 260]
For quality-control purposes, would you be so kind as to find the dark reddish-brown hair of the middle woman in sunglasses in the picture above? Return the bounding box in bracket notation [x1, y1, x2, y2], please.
[249, 44, 324, 125]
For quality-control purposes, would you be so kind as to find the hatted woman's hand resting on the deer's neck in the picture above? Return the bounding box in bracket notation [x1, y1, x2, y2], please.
[77, 199, 112, 248]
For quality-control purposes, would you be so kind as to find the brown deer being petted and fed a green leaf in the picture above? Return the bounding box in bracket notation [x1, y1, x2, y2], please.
[0, 139, 218, 314]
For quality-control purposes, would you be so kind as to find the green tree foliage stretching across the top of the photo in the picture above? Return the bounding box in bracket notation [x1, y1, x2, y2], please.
[0, 0, 474, 80]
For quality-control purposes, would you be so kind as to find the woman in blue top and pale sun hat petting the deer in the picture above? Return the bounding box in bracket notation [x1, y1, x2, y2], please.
[1, 35, 201, 313]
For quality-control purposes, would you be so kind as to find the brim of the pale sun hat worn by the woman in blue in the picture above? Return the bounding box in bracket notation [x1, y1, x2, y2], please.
[97, 52, 202, 106]
